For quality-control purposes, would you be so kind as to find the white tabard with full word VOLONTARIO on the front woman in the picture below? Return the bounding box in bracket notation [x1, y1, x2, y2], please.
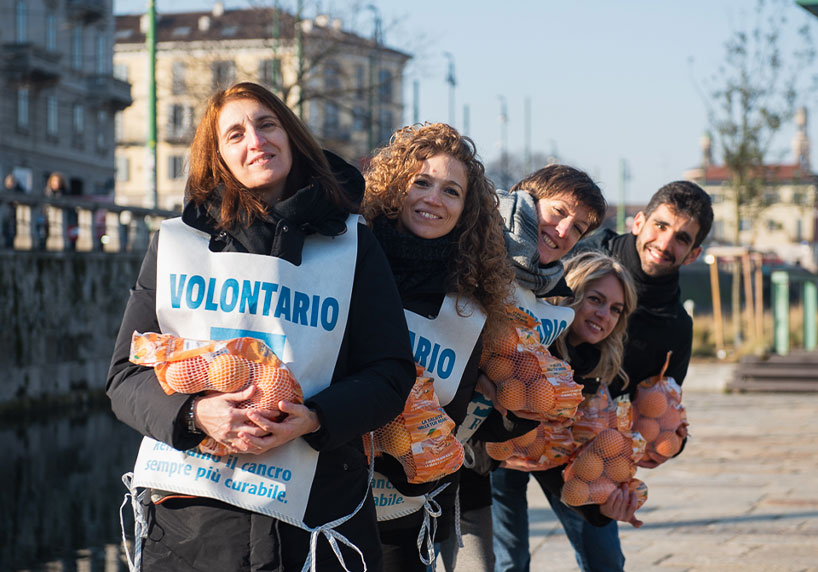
[134, 216, 359, 525]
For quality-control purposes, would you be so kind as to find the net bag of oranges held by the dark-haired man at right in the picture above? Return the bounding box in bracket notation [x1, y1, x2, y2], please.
[633, 352, 687, 458]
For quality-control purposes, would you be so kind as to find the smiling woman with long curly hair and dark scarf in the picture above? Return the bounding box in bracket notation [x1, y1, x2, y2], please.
[362, 123, 513, 571]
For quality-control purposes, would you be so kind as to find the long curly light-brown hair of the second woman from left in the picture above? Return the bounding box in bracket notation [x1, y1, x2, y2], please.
[361, 123, 514, 338]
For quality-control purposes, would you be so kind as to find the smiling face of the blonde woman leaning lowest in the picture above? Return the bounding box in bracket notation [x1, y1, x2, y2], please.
[567, 274, 625, 346]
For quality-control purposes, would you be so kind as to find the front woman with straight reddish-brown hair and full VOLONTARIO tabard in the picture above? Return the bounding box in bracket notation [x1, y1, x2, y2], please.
[107, 83, 415, 571]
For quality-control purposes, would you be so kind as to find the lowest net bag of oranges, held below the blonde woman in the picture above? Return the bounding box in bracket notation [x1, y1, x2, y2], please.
[562, 429, 645, 506]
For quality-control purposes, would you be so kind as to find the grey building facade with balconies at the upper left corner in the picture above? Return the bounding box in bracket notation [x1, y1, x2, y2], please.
[0, 0, 131, 198]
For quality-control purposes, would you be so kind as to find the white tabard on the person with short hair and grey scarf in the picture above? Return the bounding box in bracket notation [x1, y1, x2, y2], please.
[457, 284, 574, 443]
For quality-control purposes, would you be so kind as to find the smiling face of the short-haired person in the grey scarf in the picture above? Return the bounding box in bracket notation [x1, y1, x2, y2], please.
[537, 194, 591, 264]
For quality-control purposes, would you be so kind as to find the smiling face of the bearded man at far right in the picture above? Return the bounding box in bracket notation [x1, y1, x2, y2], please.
[632, 204, 702, 277]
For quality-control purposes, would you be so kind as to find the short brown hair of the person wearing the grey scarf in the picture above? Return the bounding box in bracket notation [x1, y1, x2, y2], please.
[510, 164, 608, 234]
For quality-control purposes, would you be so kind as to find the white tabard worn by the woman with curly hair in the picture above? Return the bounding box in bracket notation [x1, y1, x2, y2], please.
[372, 294, 486, 520]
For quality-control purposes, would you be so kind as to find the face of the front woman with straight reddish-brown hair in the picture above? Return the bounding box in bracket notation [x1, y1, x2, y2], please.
[218, 99, 293, 203]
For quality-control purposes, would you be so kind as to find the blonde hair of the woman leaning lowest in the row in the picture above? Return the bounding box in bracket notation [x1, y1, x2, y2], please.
[550, 251, 637, 388]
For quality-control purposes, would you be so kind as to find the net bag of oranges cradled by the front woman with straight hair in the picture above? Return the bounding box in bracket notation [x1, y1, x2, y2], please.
[130, 332, 304, 410]
